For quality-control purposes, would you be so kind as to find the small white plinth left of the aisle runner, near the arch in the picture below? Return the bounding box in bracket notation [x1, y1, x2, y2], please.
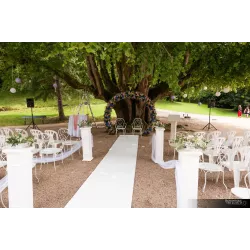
[81, 127, 93, 161]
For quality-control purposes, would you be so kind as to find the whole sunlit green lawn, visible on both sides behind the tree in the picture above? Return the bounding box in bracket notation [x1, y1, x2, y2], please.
[0, 92, 237, 126]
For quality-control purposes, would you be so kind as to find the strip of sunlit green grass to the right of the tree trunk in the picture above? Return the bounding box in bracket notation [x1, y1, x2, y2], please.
[155, 100, 237, 117]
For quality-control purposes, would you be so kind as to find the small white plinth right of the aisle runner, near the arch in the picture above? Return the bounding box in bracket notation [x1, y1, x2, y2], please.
[152, 127, 165, 163]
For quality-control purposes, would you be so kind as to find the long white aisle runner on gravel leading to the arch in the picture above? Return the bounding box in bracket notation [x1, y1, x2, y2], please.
[66, 135, 138, 208]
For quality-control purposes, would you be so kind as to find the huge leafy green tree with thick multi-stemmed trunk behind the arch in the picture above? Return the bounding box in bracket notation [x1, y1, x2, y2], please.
[0, 41, 250, 125]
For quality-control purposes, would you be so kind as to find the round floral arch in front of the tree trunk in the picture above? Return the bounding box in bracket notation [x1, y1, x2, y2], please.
[104, 91, 156, 135]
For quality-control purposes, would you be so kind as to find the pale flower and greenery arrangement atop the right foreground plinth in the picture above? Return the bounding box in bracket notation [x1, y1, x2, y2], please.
[170, 133, 209, 150]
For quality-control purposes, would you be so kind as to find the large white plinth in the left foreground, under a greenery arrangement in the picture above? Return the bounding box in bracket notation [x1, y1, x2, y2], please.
[3, 147, 33, 208]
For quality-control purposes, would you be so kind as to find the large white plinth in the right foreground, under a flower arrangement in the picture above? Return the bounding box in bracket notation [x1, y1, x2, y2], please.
[175, 149, 202, 208]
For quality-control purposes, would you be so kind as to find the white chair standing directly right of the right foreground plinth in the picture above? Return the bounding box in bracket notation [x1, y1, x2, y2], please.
[199, 151, 227, 192]
